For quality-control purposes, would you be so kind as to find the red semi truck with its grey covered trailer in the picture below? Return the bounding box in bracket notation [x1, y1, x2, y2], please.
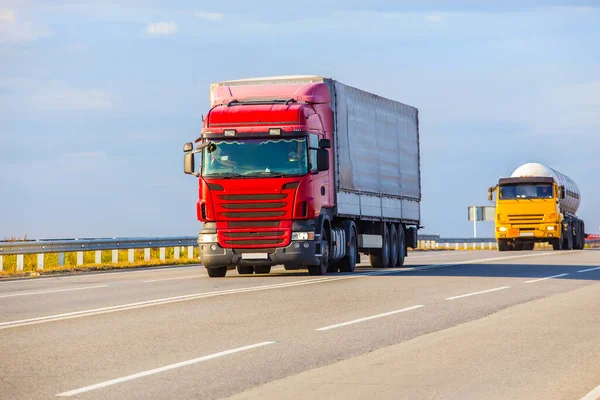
[184, 76, 421, 277]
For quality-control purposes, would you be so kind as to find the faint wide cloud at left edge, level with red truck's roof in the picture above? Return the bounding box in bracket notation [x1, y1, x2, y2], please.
[0, 78, 115, 113]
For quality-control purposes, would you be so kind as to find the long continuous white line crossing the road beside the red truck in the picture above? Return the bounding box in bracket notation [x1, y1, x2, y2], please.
[0, 252, 555, 330]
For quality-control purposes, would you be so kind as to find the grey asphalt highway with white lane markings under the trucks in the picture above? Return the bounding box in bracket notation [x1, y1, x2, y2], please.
[0, 250, 600, 400]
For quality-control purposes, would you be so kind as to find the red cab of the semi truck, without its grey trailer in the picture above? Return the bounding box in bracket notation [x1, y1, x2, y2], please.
[180, 83, 334, 276]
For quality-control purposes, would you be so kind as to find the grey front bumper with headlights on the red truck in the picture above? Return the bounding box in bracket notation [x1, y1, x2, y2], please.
[198, 241, 321, 267]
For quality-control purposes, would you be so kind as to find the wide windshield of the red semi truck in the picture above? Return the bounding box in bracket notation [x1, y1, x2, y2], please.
[202, 137, 308, 177]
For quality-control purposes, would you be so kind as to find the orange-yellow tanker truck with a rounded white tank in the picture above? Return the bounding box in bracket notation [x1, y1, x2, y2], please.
[488, 163, 585, 251]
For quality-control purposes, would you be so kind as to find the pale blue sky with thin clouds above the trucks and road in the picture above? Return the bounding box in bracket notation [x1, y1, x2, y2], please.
[0, 0, 600, 238]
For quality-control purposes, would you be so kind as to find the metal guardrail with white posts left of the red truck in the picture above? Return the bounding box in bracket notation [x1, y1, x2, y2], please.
[0, 236, 198, 271]
